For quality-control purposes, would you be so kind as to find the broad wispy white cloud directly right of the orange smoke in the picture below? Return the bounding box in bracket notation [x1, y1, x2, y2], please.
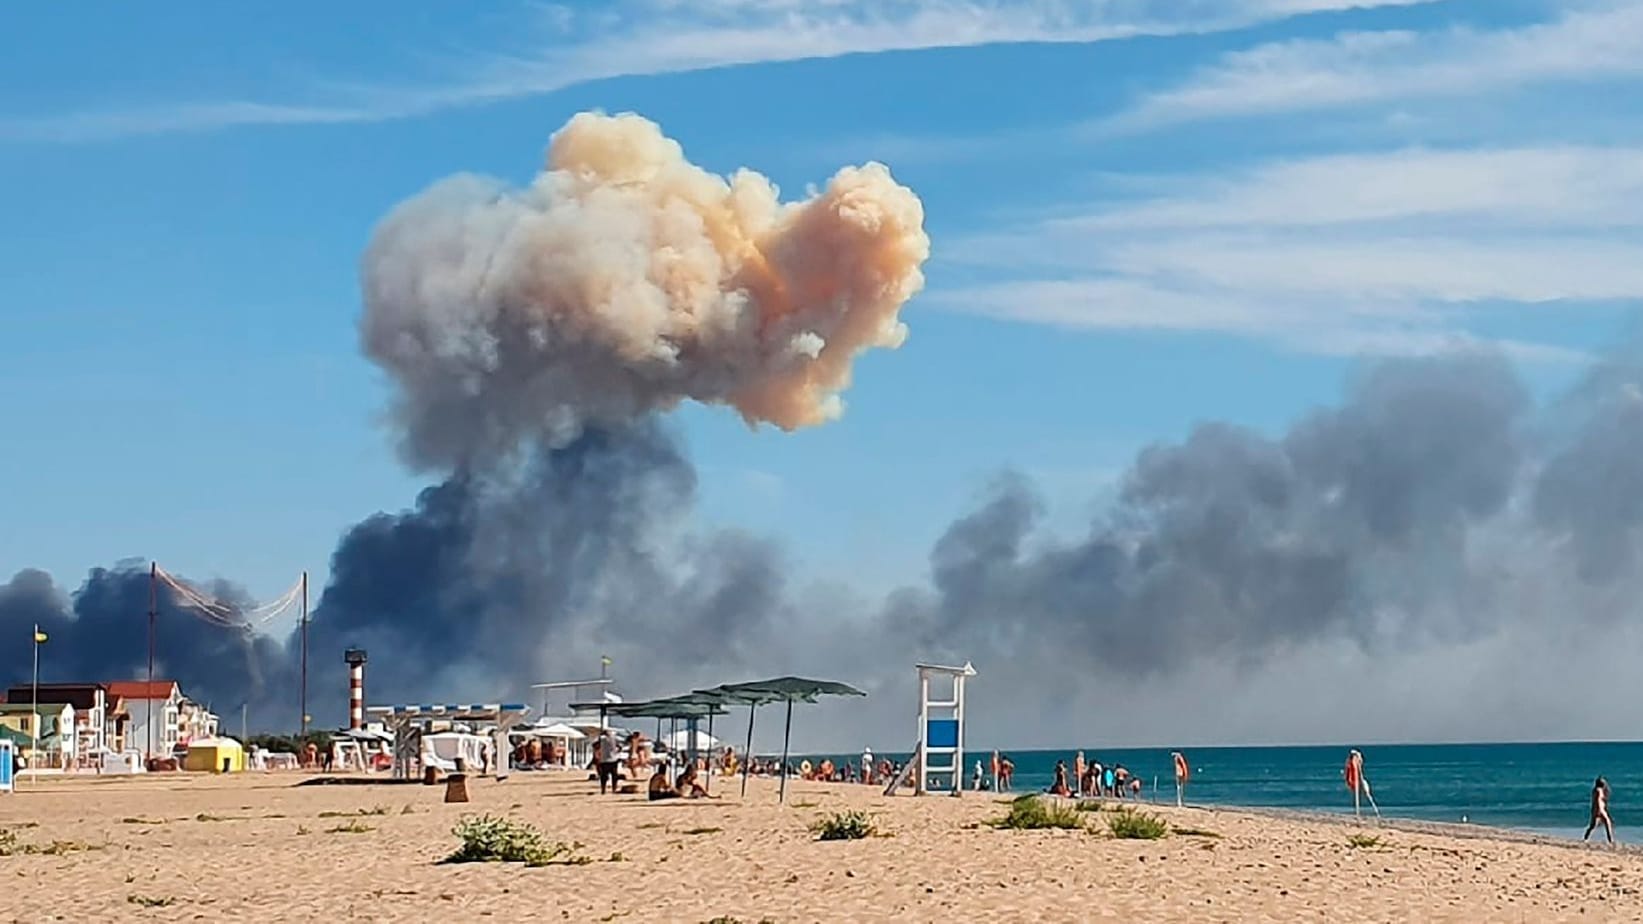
[928, 148, 1643, 360]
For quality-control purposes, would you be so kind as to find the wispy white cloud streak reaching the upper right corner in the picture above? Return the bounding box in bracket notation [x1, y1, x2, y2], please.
[1102, 0, 1643, 132]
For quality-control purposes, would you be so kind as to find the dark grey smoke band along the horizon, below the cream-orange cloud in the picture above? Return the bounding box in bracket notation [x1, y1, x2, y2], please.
[9, 345, 1643, 743]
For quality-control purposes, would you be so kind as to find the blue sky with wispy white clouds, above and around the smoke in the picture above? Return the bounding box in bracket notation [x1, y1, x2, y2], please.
[0, 0, 1643, 611]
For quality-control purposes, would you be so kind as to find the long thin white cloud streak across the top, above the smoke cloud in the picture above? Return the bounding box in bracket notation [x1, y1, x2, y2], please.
[0, 0, 1433, 141]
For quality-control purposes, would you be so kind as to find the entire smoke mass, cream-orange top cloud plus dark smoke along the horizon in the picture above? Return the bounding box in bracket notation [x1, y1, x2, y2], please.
[9, 115, 1643, 745]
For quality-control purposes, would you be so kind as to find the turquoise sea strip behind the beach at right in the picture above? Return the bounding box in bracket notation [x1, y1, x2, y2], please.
[794, 742, 1643, 843]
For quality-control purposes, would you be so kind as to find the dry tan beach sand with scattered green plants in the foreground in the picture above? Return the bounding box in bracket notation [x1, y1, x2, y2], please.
[0, 773, 1643, 924]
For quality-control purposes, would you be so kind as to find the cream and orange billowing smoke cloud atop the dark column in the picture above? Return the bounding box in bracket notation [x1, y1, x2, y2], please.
[361, 113, 930, 470]
